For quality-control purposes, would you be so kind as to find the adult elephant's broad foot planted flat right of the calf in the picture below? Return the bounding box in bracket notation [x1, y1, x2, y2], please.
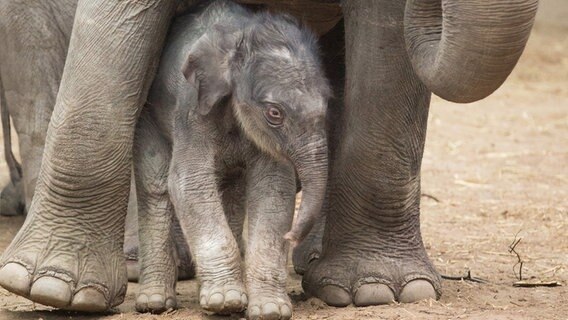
[302, 249, 441, 307]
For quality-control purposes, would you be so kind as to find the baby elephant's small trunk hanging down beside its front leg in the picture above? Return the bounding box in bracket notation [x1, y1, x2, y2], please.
[284, 134, 328, 246]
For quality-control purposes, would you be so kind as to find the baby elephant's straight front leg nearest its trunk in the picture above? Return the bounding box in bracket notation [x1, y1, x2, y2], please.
[245, 158, 296, 320]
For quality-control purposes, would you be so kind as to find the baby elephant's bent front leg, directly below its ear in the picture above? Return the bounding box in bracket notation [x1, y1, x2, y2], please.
[169, 146, 247, 314]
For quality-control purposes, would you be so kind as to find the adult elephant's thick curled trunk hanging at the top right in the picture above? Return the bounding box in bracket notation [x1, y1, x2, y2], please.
[404, 0, 538, 103]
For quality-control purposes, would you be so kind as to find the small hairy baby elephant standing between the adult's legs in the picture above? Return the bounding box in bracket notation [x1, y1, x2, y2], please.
[134, 1, 330, 319]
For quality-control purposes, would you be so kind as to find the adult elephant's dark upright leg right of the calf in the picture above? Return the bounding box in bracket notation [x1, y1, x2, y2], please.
[303, 0, 440, 306]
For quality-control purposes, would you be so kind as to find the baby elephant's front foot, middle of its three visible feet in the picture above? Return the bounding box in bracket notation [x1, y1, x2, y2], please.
[199, 283, 248, 314]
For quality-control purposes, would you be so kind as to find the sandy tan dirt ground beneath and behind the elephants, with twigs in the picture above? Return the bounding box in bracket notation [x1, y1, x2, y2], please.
[0, 0, 568, 320]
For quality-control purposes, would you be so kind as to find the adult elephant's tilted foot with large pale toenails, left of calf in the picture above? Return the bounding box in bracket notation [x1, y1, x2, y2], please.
[0, 217, 127, 312]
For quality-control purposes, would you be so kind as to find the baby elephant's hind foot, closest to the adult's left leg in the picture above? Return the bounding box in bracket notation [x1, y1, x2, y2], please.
[136, 287, 177, 313]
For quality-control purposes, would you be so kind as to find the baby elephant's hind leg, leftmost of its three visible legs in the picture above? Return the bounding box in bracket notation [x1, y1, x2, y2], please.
[134, 114, 177, 313]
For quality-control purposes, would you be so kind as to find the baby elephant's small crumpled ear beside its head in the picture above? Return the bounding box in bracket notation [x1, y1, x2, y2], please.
[182, 26, 240, 115]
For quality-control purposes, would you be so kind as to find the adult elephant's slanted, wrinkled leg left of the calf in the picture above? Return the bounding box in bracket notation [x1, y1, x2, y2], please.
[0, 0, 175, 311]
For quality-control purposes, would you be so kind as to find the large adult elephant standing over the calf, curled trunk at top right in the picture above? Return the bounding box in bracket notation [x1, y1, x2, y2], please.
[0, 0, 537, 311]
